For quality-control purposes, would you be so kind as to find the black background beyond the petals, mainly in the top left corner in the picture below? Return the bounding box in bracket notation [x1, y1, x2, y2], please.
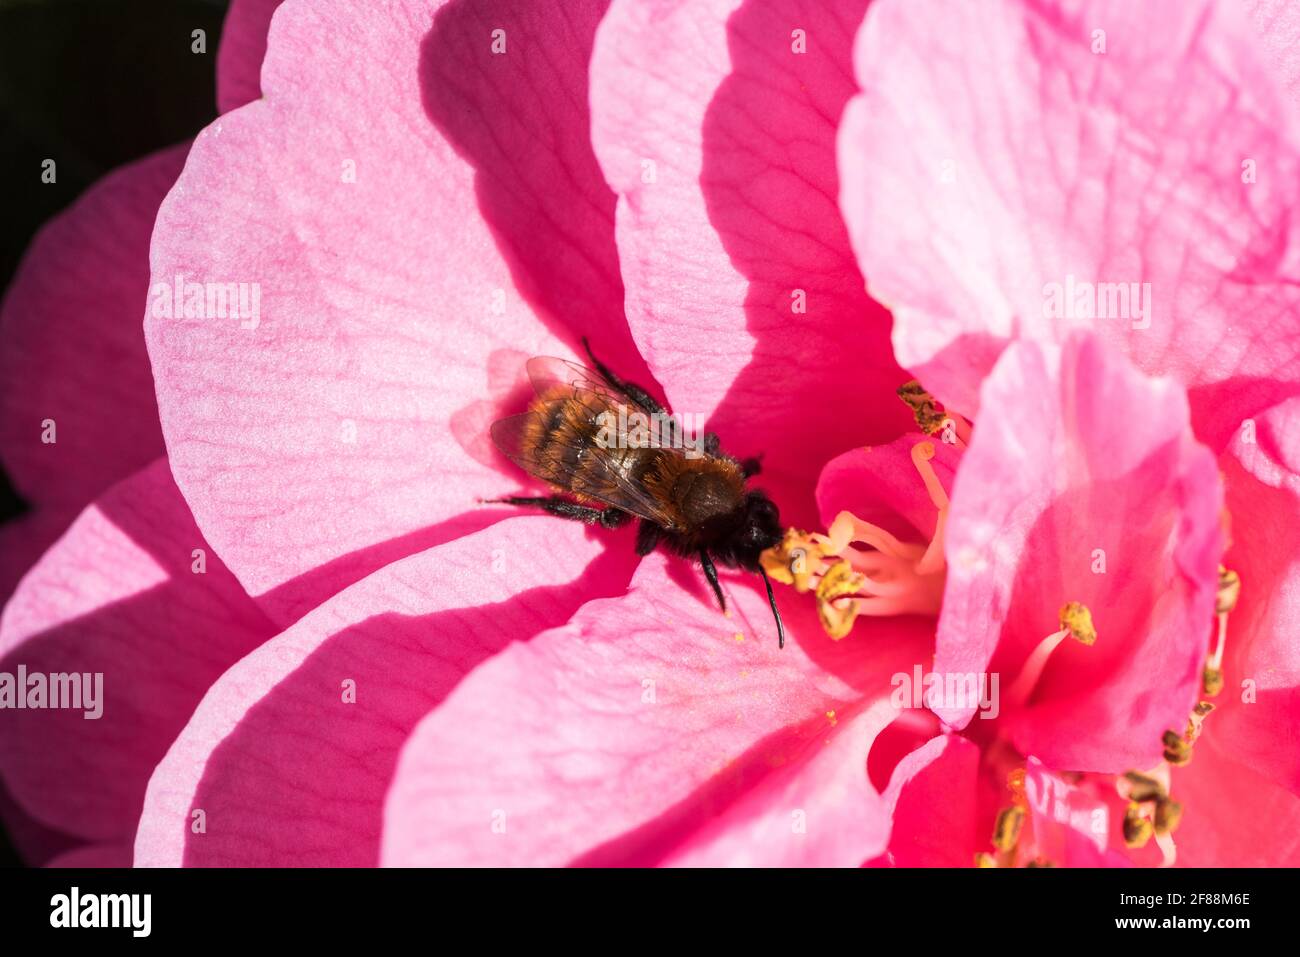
[0, 0, 228, 866]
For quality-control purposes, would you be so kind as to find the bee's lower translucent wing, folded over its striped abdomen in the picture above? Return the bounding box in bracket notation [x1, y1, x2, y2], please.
[491, 411, 677, 528]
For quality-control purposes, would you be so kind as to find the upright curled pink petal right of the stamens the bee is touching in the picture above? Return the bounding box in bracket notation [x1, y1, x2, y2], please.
[935, 335, 1222, 772]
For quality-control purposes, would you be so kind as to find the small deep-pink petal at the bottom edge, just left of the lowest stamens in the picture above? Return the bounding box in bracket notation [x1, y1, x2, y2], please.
[881, 735, 983, 867]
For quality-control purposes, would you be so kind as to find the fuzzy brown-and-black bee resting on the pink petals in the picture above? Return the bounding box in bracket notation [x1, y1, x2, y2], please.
[491, 337, 785, 648]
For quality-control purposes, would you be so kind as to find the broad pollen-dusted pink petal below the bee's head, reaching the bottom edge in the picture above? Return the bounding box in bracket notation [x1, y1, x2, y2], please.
[382, 555, 928, 866]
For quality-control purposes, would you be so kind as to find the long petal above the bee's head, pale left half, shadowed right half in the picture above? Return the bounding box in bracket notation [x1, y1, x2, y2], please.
[592, 0, 907, 520]
